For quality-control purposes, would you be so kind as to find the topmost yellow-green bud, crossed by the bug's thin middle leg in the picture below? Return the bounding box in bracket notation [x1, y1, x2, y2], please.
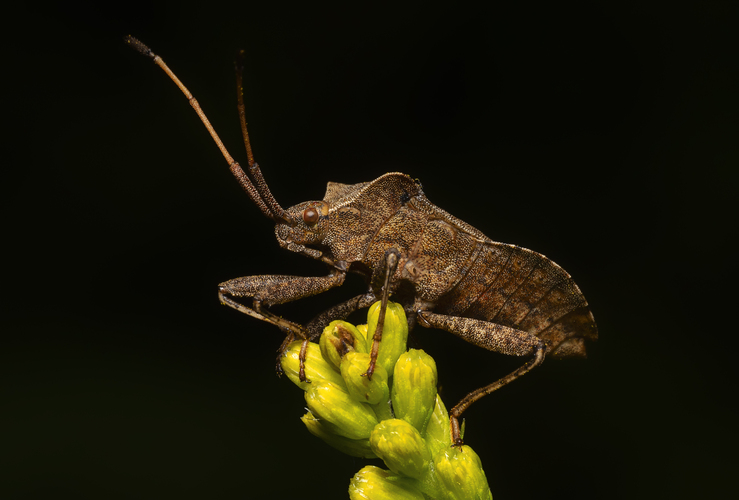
[367, 301, 408, 373]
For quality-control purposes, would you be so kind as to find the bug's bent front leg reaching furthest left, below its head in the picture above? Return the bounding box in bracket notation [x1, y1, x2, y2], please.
[218, 269, 346, 380]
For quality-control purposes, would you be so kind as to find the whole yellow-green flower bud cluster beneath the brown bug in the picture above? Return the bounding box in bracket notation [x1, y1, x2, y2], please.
[281, 302, 492, 500]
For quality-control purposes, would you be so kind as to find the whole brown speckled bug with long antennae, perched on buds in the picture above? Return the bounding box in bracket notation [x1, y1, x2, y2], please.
[127, 37, 598, 445]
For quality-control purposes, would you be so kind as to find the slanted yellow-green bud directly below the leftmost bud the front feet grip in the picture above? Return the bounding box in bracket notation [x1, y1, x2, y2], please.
[305, 382, 377, 439]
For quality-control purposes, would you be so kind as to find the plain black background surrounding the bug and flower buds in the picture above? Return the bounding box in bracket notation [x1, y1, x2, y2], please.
[0, 2, 739, 499]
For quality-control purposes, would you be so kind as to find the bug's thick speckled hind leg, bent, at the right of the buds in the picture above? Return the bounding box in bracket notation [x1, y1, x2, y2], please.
[418, 311, 546, 446]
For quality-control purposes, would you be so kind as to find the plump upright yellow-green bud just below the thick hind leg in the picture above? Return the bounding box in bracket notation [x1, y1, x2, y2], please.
[392, 349, 437, 434]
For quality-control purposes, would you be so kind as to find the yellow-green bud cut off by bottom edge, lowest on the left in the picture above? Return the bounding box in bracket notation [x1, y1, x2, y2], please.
[349, 465, 424, 500]
